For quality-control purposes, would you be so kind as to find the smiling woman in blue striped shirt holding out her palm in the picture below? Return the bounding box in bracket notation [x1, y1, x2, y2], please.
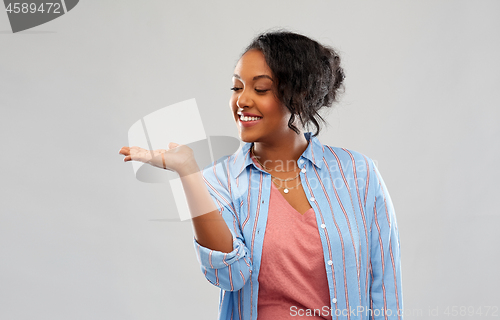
[120, 31, 402, 320]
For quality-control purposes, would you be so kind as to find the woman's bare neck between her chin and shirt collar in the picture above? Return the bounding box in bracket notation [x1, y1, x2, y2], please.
[253, 131, 309, 171]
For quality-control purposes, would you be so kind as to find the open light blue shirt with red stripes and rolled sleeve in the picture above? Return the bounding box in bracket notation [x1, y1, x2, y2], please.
[194, 132, 403, 320]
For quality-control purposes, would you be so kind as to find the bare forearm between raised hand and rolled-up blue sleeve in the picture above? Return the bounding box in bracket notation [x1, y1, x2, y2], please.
[179, 163, 233, 252]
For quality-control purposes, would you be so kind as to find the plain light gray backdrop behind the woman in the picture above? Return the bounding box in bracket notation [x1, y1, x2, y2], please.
[0, 0, 500, 320]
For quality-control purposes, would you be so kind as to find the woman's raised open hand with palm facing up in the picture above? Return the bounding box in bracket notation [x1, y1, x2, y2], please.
[119, 142, 198, 175]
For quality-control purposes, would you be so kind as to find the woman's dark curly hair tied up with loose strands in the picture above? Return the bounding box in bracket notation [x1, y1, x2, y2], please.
[244, 30, 345, 136]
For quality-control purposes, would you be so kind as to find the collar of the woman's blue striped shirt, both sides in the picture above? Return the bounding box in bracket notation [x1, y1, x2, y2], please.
[228, 132, 324, 178]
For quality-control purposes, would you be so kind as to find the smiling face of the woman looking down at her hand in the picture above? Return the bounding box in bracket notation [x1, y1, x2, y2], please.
[229, 50, 293, 142]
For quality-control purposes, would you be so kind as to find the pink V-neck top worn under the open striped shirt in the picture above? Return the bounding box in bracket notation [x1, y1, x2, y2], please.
[257, 183, 332, 320]
